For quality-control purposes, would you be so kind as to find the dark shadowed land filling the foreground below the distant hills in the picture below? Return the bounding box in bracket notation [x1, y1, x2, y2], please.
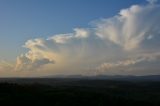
[0, 79, 160, 106]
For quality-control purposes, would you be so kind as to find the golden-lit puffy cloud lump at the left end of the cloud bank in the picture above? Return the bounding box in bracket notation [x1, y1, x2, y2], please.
[15, 39, 54, 70]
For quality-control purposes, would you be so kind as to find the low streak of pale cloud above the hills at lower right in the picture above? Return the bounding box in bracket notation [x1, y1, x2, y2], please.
[95, 53, 160, 74]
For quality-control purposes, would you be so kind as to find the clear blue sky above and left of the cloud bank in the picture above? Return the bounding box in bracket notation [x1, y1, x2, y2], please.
[0, 0, 146, 60]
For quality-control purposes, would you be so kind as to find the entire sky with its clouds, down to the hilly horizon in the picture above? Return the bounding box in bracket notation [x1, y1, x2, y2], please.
[0, 0, 160, 77]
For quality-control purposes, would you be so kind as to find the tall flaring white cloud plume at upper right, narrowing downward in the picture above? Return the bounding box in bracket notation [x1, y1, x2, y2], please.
[96, 5, 160, 50]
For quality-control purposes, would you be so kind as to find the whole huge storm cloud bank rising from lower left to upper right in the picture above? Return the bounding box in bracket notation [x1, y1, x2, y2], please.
[13, 0, 160, 73]
